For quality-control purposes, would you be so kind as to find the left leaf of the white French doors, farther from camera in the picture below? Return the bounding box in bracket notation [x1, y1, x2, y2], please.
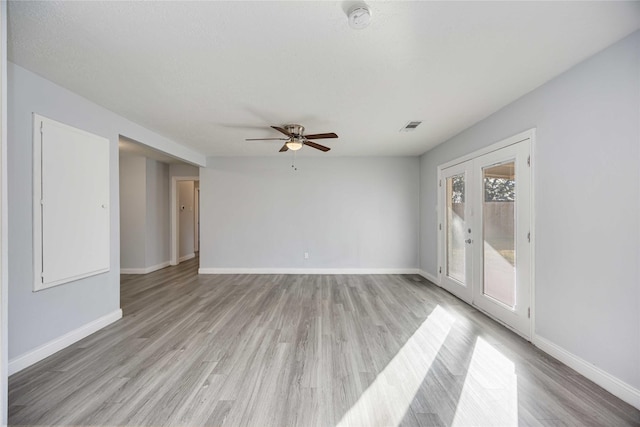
[440, 161, 473, 303]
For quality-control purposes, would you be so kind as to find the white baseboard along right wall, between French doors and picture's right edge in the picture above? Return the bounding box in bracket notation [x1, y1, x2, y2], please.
[532, 334, 640, 409]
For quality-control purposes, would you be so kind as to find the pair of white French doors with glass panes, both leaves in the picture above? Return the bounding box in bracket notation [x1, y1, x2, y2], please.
[439, 138, 531, 338]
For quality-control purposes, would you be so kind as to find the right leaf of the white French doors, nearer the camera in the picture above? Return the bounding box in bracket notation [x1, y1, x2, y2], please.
[472, 140, 531, 338]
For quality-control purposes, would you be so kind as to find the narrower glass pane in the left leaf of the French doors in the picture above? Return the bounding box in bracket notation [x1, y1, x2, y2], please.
[446, 174, 466, 284]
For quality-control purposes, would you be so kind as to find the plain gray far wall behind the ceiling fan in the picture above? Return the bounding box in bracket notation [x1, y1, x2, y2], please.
[200, 157, 419, 269]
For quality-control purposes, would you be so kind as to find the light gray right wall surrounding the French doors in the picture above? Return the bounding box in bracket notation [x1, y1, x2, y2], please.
[420, 32, 640, 388]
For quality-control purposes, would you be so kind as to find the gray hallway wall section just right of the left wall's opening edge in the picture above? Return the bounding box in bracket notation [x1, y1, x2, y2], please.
[120, 156, 147, 268]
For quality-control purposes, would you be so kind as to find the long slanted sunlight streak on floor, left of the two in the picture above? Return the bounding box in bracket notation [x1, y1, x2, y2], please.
[338, 306, 455, 427]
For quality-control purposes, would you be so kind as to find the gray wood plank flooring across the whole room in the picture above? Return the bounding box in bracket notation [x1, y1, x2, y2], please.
[9, 259, 640, 426]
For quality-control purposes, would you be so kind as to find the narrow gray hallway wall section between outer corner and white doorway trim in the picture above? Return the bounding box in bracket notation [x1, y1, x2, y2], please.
[145, 159, 171, 267]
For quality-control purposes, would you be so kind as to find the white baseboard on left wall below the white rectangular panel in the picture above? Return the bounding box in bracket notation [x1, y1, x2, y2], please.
[9, 309, 122, 375]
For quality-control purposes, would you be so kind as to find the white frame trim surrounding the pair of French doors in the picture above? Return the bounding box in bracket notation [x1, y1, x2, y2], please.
[436, 128, 536, 341]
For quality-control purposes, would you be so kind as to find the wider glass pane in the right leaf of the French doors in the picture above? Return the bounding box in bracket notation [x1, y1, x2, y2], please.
[482, 161, 516, 308]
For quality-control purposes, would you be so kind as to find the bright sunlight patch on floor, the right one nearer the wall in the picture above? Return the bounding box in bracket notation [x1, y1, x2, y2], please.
[451, 337, 518, 426]
